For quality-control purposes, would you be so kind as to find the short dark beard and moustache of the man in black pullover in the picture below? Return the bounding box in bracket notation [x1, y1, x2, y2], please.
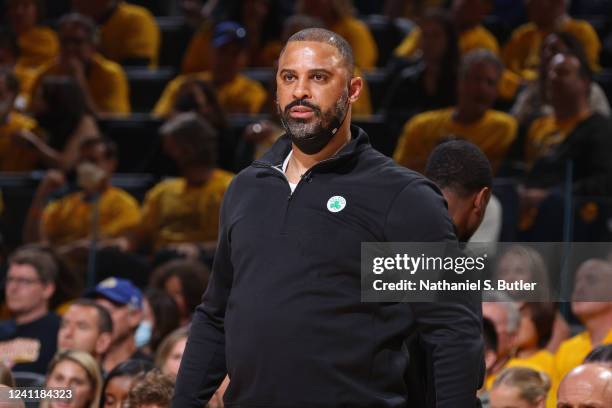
[278, 90, 348, 140]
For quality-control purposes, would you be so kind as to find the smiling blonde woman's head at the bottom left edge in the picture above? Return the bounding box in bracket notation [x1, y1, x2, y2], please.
[40, 350, 102, 408]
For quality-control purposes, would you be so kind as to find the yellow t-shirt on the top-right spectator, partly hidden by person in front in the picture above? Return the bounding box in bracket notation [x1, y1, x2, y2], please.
[502, 18, 601, 80]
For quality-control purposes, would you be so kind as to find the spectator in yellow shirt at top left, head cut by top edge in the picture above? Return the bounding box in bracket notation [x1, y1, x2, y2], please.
[72, 0, 160, 67]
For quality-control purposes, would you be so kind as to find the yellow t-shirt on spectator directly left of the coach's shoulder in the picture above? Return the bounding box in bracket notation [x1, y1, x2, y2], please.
[139, 169, 233, 249]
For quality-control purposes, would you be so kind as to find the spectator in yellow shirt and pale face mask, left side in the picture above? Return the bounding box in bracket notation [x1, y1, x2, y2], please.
[24, 137, 140, 255]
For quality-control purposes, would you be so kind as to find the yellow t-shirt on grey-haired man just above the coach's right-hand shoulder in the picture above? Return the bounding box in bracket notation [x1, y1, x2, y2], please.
[393, 108, 517, 173]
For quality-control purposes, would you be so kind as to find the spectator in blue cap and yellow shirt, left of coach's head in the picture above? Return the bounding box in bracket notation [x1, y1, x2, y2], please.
[153, 21, 267, 117]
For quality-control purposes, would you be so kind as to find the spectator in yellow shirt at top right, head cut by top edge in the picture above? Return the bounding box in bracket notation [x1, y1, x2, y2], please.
[503, 0, 601, 80]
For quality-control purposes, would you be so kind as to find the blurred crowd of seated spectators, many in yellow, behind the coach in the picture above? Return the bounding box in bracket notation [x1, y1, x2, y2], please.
[0, 0, 612, 408]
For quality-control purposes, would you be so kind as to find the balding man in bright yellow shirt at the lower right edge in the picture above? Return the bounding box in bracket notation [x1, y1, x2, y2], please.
[555, 259, 612, 384]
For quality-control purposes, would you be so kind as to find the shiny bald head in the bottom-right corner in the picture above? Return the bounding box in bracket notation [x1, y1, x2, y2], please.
[557, 363, 612, 408]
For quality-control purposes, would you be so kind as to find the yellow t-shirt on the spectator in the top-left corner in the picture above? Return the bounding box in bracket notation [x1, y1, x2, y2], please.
[17, 26, 59, 68]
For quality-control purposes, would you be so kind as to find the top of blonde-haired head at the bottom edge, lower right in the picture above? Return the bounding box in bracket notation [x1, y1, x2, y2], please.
[490, 367, 550, 408]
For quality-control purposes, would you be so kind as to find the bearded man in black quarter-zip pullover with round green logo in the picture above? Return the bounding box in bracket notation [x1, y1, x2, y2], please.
[173, 28, 482, 408]
